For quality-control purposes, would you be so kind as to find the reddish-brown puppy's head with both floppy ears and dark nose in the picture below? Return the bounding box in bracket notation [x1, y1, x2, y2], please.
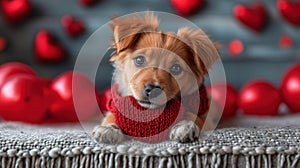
[111, 13, 218, 108]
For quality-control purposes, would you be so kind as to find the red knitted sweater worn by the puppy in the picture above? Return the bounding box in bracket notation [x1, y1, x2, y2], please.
[99, 84, 209, 143]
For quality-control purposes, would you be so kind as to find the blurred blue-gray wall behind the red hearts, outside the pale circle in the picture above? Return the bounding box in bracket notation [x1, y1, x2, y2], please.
[0, 0, 300, 89]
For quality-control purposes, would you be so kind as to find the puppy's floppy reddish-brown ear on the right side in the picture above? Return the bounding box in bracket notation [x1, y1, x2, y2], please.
[177, 27, 221, 75]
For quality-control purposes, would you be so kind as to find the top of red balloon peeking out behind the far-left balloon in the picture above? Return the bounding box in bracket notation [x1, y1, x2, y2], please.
[0, 62, 37, 87]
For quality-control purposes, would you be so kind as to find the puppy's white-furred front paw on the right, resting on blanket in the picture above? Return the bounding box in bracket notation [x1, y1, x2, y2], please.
[170, 120, 200, 143]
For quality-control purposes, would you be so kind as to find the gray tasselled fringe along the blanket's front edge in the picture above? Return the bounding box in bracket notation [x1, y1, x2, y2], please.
[0, 153, 300, 168]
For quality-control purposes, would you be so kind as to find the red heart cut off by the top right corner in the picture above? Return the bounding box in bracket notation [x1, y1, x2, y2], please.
[277, 0, 300, 26]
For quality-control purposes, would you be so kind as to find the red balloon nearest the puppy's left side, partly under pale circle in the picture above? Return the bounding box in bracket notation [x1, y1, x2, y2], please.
[49, 72, 98, 122]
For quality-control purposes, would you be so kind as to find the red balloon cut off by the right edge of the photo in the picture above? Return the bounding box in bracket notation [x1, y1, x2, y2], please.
[280, 64, 300, 112]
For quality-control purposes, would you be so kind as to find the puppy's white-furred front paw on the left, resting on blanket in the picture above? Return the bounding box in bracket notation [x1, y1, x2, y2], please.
[92, 125, 124, 143]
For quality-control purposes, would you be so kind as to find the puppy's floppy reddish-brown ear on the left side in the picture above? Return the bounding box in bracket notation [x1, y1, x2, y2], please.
[110, 12, 159, 60]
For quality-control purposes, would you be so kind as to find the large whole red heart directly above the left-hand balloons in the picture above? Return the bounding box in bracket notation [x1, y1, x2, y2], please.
[35, 30, 66, 63]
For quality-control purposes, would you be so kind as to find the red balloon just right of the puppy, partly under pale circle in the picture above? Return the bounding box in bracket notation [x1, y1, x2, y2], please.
[208, 83, 238, 119]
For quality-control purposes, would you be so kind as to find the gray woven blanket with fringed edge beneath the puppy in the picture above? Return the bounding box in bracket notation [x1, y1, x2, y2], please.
[0, 117, 300, 168]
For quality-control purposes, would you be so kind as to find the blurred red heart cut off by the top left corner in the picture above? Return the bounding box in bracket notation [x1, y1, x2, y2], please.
[1, 0, 31, 25]
